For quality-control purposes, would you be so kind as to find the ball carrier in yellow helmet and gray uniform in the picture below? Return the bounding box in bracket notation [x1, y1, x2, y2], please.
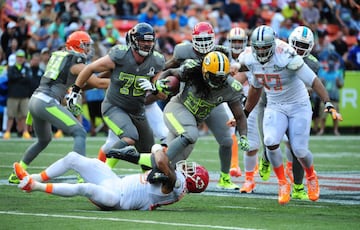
[159, 51, 249, 180]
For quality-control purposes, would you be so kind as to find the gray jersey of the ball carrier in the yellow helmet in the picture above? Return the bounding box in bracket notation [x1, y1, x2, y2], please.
[171, 76, 242, 122]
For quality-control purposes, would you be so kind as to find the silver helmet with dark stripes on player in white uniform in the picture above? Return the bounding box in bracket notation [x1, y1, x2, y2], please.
[250, 25, 276, 64]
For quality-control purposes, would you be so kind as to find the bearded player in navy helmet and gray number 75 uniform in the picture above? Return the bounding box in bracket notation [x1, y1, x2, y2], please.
[73, 23, 166, 168]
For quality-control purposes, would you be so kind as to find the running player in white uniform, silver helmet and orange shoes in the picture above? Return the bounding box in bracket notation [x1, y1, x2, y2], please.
[238, 25, 341, 204]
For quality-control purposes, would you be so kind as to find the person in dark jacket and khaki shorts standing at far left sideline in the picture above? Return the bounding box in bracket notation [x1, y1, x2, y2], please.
[3, 49, 32, 139]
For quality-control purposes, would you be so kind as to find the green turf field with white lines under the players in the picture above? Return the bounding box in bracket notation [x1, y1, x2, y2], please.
[0, 136, 360, 230]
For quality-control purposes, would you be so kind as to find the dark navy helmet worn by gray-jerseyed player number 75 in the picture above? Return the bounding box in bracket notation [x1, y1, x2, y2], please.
[128, 22, 155, 57]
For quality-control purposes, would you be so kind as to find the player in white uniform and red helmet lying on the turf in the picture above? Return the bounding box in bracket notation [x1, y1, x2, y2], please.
[14, 144, 209, 210]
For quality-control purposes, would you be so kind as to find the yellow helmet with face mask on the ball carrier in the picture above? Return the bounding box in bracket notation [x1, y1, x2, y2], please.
[202, 51, 230, 89]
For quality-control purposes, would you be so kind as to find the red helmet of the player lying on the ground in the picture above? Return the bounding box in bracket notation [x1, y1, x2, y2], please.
[176, 160, 209, 193]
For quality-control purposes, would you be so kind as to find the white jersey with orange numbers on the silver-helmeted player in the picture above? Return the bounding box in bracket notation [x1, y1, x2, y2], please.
[238, 39, 316, 104]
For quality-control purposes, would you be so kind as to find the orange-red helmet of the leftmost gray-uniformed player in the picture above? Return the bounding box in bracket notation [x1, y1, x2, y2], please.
[66, 31, 92, 54]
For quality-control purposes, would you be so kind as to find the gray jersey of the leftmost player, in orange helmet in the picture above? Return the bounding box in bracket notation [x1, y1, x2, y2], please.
[34, 51, 86, 102]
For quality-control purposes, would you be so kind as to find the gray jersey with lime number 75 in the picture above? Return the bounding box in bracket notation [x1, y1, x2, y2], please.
[105, 45, 165, 114]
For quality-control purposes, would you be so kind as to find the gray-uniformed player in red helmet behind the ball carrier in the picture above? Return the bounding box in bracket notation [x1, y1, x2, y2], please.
[165, 22, 247, 190]
